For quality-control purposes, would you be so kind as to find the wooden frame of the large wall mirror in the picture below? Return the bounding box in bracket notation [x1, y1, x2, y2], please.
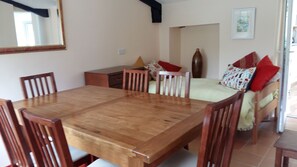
[0, 0, 66, 54]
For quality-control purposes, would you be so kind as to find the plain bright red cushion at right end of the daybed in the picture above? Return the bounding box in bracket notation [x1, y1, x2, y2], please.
[251, 55, 279, 91]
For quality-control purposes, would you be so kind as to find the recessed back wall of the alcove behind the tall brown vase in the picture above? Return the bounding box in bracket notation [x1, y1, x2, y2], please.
[179, 24, 219, 79]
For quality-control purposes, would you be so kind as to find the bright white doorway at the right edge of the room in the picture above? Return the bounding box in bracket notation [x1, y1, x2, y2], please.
[277, 0, 297, 132]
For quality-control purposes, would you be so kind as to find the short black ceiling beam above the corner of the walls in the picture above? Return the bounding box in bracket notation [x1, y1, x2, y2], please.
[140, 0, 162, 23]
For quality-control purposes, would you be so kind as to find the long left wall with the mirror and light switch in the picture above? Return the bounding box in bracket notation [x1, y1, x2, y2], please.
[0, 0, 159, 166]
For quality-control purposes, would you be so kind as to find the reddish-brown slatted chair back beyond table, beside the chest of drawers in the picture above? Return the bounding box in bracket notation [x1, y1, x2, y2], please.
[123, 69, 149, 92]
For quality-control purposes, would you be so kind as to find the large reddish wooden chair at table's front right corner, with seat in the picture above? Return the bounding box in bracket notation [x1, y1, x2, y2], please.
[159, 92, 243, 167]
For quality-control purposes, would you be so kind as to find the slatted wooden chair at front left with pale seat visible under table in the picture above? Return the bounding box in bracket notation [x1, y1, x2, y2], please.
[20, 109, 92, 167]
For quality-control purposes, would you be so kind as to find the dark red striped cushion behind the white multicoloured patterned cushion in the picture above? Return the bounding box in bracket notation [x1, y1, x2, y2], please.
[233, 52, 258, 68]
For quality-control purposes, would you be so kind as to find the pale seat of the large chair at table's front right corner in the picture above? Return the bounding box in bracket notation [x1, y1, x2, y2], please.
[158, 149, 198, 167]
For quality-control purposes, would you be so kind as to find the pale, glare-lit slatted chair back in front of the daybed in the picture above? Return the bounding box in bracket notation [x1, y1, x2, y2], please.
[156, 71, 191, 98]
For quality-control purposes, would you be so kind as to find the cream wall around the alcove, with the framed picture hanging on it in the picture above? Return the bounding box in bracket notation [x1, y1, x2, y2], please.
[160, 0, 279, 76]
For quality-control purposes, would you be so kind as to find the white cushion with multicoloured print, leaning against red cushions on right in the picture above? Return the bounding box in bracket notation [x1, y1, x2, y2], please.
[220, 65, 256, 92]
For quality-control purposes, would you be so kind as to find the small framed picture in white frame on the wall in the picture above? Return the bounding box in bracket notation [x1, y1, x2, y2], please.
[232, 8, 256, 39]
